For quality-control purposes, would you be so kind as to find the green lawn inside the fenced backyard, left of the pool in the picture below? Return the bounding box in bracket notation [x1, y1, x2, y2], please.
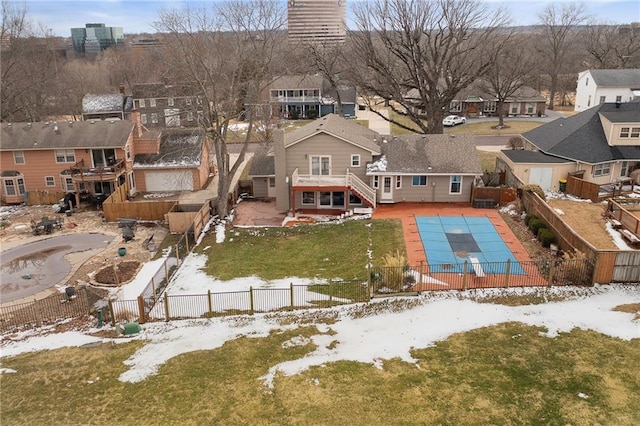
[196, 220, 405, 280]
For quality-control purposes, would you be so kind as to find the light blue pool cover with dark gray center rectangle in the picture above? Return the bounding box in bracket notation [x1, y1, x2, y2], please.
[416, 216, 524, 275]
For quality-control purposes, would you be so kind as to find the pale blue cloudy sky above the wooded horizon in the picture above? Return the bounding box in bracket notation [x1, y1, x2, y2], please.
[22, 0, 640, 37]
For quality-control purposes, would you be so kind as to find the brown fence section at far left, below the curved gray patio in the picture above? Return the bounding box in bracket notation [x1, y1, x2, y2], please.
[0, 288, 92, 333]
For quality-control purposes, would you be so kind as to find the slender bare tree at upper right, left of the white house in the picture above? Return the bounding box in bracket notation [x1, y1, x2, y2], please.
[537, 3, 587, 110]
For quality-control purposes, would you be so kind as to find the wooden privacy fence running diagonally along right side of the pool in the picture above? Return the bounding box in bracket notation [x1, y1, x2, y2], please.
[522, 191, 640, 284]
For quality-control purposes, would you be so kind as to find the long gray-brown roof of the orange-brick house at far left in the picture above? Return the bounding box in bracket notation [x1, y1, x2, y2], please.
[0, 120, 133, 151]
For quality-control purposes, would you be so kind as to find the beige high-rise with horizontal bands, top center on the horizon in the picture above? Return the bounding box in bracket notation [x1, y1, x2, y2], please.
[288, 0, 347, 43]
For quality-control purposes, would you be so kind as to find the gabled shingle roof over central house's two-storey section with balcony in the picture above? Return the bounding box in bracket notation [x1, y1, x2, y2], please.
[284, 114, 380, 154]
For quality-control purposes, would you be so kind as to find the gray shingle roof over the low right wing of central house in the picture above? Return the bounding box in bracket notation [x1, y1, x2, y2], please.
[367, 135, 482, 175]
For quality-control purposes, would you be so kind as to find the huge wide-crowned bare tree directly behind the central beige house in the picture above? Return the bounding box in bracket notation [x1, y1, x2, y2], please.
[350, 0, 509, 133]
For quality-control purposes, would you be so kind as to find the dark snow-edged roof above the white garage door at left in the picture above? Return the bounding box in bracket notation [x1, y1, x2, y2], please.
[133, 130, 204, 168]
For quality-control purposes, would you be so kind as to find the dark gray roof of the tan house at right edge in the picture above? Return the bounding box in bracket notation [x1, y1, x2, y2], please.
[522, 102, 640, 164]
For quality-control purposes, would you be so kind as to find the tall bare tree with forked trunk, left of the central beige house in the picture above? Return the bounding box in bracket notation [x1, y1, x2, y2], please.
[155, 0, 286, 217]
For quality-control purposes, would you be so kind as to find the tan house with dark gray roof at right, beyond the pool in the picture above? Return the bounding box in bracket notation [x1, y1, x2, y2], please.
[498, 101, 640, 191]
